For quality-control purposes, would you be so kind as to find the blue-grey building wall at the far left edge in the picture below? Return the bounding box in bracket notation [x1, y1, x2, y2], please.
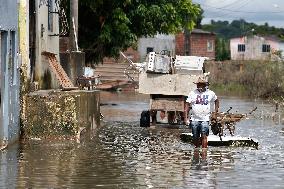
[0, 0, 21, 148]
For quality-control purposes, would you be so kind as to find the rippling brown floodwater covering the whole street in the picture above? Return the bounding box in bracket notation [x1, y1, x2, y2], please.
[0, 92, 284, 189]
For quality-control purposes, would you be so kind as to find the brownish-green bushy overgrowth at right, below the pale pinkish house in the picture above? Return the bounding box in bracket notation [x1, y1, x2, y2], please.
[206, 61, 284, 98]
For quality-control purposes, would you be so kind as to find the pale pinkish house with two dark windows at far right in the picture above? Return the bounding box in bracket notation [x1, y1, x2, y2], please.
[230, 35, 284, 60]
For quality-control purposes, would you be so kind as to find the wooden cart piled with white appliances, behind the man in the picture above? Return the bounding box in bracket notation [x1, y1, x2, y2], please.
[138, 52, 208, 127]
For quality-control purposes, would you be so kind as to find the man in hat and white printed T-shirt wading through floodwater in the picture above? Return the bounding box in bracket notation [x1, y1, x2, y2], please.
[185, 77, 219, 148]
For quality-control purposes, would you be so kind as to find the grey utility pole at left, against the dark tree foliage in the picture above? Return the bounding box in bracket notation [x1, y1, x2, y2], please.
[69, 0, 79, 51]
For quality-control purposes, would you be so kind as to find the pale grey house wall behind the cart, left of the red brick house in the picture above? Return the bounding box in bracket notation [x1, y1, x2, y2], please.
[138, 34, 175, 61]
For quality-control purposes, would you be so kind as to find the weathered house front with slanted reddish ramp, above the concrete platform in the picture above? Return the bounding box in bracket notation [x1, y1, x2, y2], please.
[29, 0, 74, 89]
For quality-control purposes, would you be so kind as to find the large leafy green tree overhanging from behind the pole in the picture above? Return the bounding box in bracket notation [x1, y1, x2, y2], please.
[79, 0, 201, 62]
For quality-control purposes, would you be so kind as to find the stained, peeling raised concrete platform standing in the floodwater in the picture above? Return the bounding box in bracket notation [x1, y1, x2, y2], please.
[23, 90, 100, 138]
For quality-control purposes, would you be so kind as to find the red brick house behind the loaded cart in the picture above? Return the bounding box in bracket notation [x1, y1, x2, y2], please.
[175, 29, 216, 59]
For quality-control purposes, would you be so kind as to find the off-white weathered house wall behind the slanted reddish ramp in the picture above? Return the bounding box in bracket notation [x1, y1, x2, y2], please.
[34, 0, 60, 88]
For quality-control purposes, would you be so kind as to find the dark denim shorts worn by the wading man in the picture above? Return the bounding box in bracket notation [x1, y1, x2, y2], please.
[191, 121, 209, 139]
